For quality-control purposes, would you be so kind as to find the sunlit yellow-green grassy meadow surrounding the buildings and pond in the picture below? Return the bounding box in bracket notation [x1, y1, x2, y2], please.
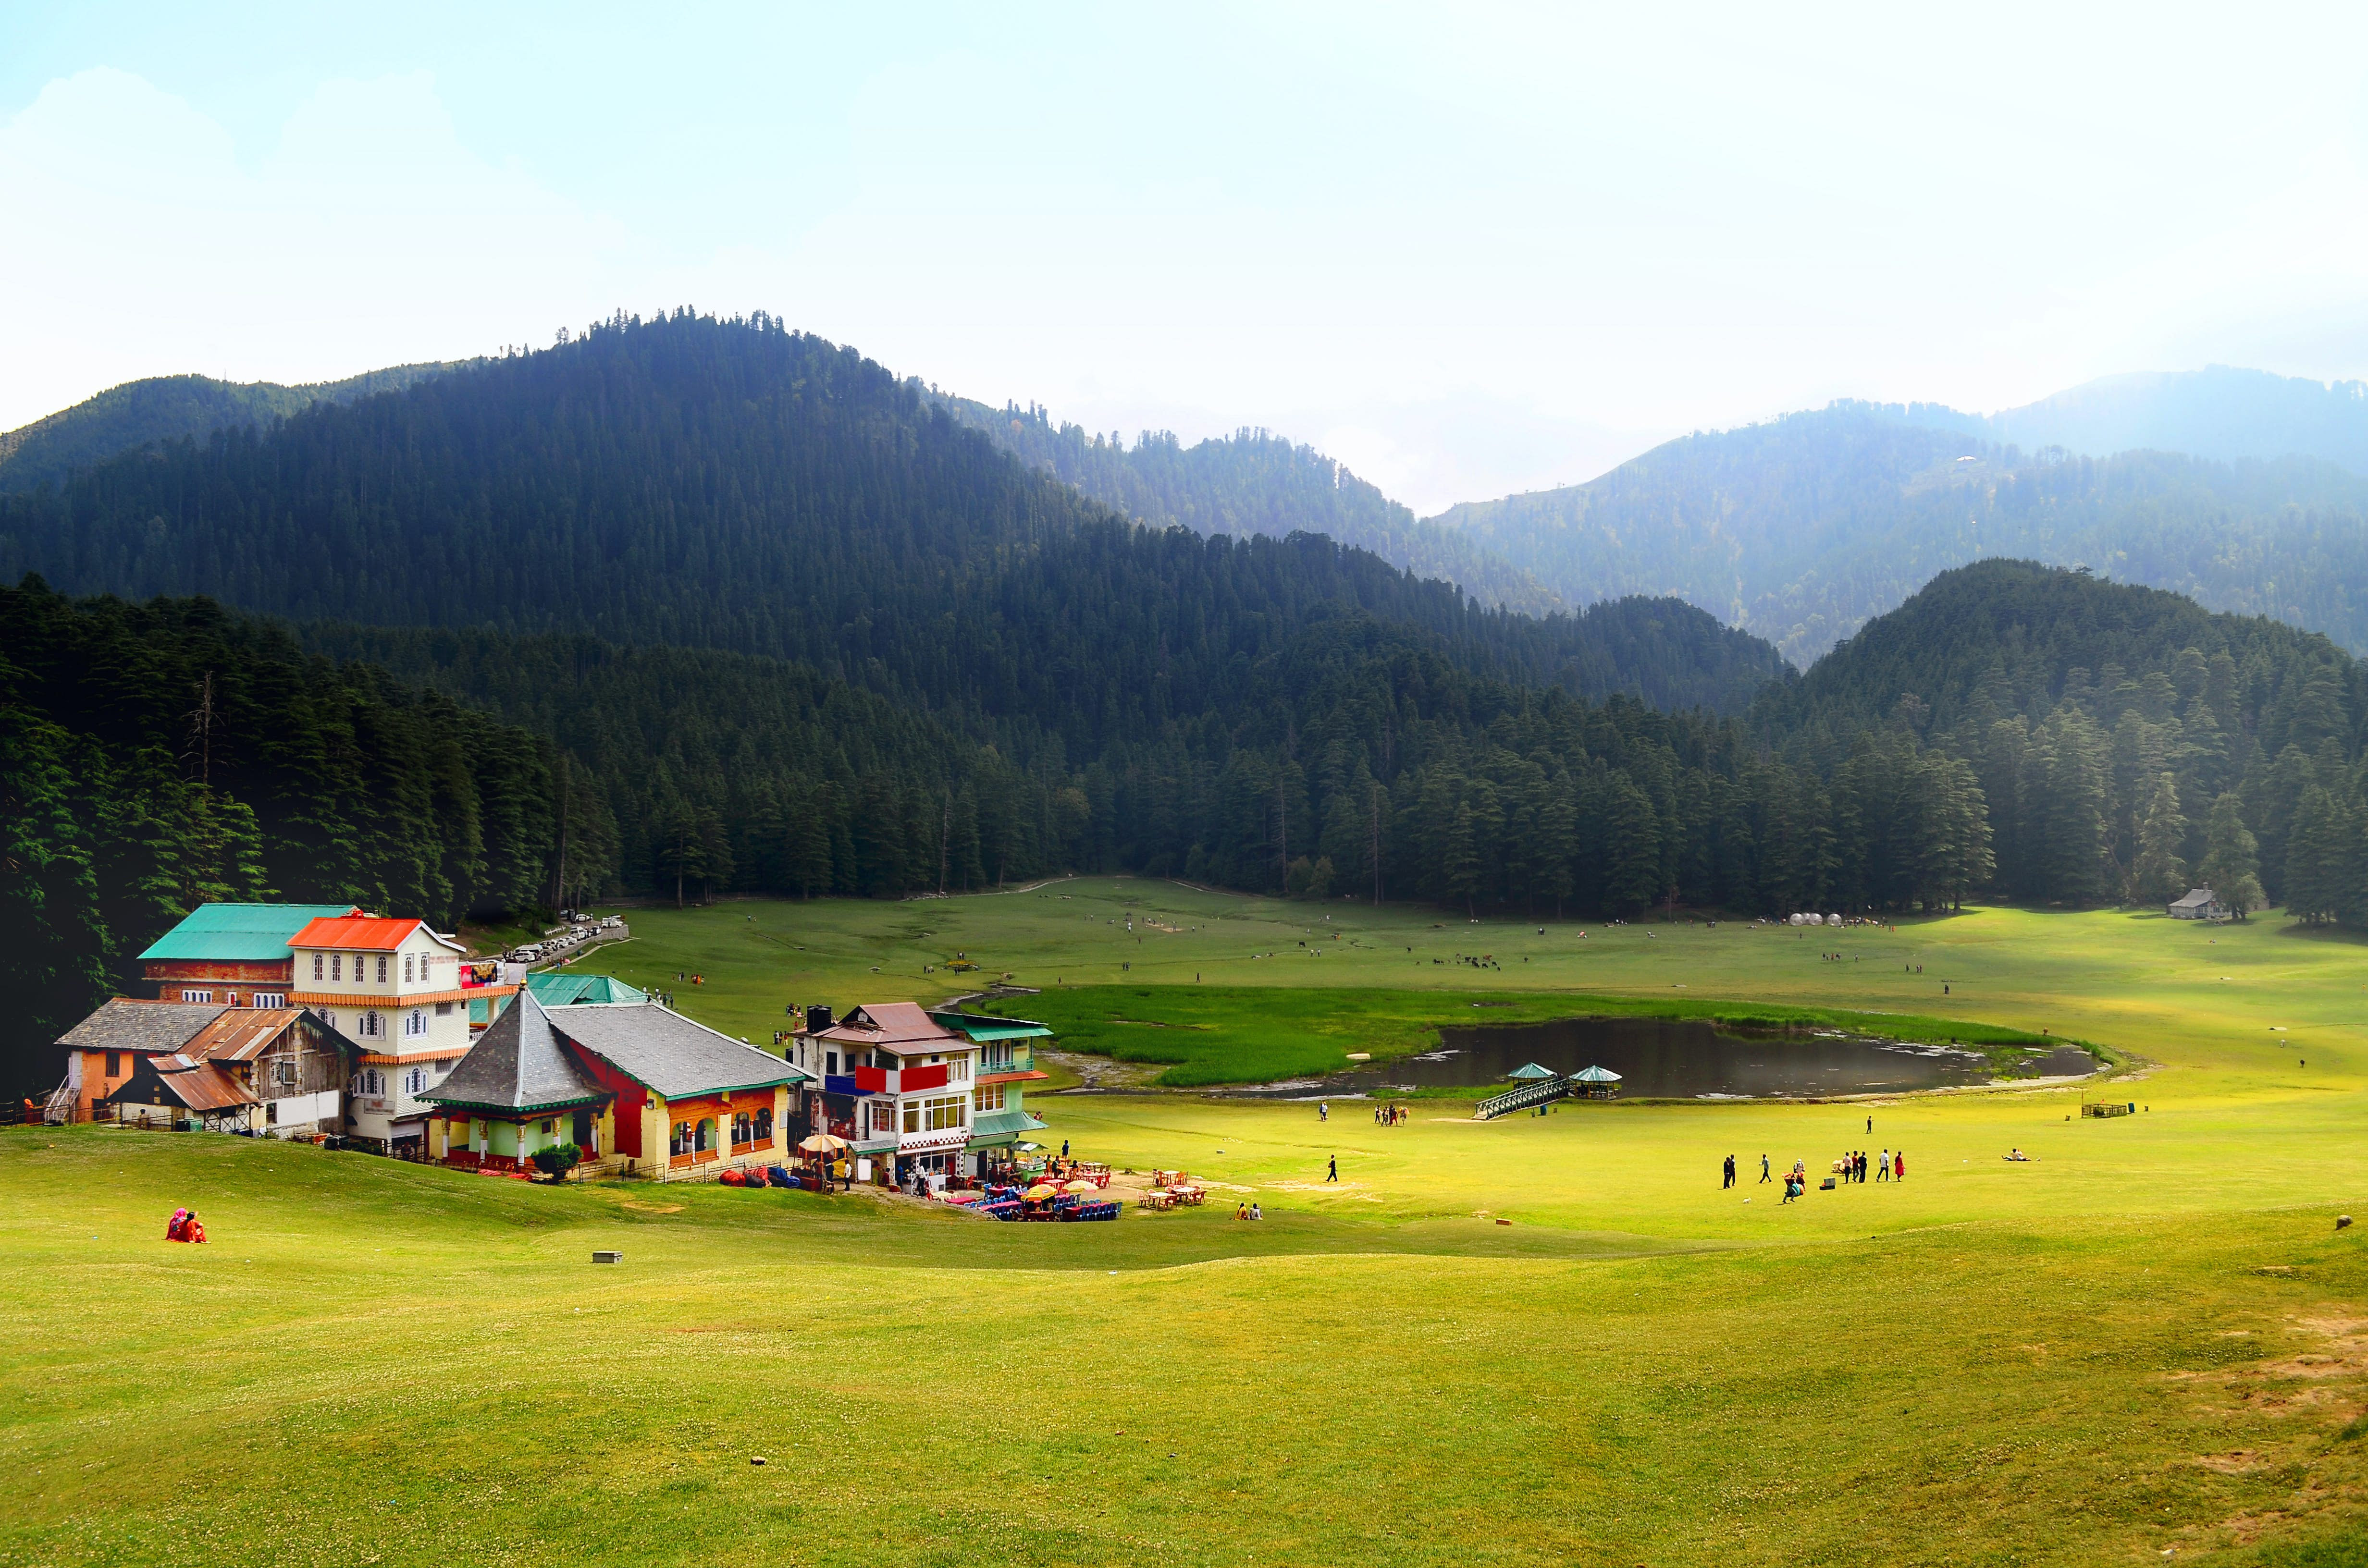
[0, 879, 2368, 1568]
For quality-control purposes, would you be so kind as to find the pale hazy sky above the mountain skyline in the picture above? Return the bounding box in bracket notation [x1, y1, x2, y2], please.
[0, 0, 2368, 512]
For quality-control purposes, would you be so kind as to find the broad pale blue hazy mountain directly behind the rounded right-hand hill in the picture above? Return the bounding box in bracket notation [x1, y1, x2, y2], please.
[1437, 403, 2368, 665]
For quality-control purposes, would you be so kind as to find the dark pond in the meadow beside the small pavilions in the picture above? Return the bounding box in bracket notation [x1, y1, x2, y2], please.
[1258, 1018, 2096, 1099]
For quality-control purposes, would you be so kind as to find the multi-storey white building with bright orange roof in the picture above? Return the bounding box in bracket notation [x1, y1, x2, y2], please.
[289, 914, 488, 1153]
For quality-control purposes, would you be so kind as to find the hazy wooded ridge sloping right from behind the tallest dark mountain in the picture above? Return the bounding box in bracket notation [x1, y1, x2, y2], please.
[931, 391, 1567, 616]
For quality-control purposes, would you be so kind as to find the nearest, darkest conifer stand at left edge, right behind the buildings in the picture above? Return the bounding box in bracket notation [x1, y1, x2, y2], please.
[0, 578, 554, 1092]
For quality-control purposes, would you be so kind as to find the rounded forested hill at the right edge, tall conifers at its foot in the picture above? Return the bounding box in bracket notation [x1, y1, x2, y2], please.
[1750, 562, 2368, 924]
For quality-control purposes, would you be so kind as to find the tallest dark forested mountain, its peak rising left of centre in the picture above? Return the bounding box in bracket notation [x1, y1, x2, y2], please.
[0, 313, 1783, 724]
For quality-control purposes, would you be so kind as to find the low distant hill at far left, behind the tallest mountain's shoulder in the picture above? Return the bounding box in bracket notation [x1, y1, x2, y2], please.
[0, 365, 466, 490]
